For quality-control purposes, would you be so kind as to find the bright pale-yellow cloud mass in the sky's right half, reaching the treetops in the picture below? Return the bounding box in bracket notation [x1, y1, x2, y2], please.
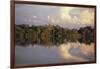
[53, 7, 94, 29]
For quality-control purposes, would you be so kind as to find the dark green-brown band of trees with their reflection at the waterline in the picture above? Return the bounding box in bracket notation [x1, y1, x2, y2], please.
[15, 24, 95, 45]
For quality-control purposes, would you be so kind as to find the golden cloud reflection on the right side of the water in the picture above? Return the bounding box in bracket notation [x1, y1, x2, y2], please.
[59, 42, 95, 61]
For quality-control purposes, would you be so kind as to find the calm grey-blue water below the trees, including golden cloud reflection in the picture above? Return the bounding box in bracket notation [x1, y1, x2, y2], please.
[15, 42, 95, 65]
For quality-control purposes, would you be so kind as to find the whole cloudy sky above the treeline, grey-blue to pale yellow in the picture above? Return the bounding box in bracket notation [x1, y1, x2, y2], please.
[15, 4, 95, 29]
